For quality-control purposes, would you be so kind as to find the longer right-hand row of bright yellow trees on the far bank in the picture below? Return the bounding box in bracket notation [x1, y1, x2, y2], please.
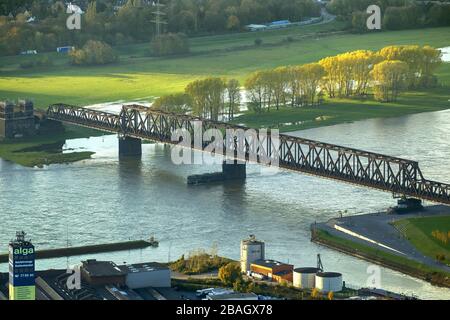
[245, 46, 441, 112]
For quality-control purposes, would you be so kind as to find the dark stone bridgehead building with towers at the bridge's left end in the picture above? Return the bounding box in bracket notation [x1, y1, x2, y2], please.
[0, 100, 36, 139]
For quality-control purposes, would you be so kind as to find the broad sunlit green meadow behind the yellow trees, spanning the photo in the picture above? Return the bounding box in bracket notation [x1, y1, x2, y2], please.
[0, 25, 450, 109]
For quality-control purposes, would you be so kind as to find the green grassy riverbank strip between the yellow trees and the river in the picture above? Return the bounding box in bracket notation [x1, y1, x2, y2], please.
[234, 84, 450, 132]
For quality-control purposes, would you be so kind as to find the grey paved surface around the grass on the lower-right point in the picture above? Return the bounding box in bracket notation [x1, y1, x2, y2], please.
[317, 205, 450, 272]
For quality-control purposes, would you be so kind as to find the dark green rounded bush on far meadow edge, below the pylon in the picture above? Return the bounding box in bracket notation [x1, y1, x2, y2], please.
[151, 33, 190, 57]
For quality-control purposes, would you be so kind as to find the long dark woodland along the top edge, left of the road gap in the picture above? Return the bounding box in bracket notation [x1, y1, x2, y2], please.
[0, 0, 320, 55]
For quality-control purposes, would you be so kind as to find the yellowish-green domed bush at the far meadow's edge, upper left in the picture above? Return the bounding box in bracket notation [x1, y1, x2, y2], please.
[69, 40, 118, 65]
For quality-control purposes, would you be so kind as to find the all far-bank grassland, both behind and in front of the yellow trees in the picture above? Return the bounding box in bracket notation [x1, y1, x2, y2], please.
[0, 26, 450, 166]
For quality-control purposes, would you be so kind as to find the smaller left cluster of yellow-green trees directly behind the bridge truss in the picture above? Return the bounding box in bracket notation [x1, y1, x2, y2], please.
[153, 77, 241, 121]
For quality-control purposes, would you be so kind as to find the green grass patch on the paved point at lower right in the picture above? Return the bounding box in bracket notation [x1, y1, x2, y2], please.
[394, 216, 450, 264]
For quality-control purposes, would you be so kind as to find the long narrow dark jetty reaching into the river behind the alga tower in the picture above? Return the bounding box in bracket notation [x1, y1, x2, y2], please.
[0, 240, 154, 263]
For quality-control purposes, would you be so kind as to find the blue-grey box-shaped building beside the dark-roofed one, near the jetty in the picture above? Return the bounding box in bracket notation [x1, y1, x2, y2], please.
[119, 263, 171, 289]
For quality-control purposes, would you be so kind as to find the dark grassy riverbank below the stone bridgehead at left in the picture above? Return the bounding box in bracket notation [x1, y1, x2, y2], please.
[0, 126, 102, 167]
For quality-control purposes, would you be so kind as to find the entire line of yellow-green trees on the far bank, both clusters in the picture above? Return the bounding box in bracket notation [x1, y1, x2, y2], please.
[153, 45, 442, 120]
